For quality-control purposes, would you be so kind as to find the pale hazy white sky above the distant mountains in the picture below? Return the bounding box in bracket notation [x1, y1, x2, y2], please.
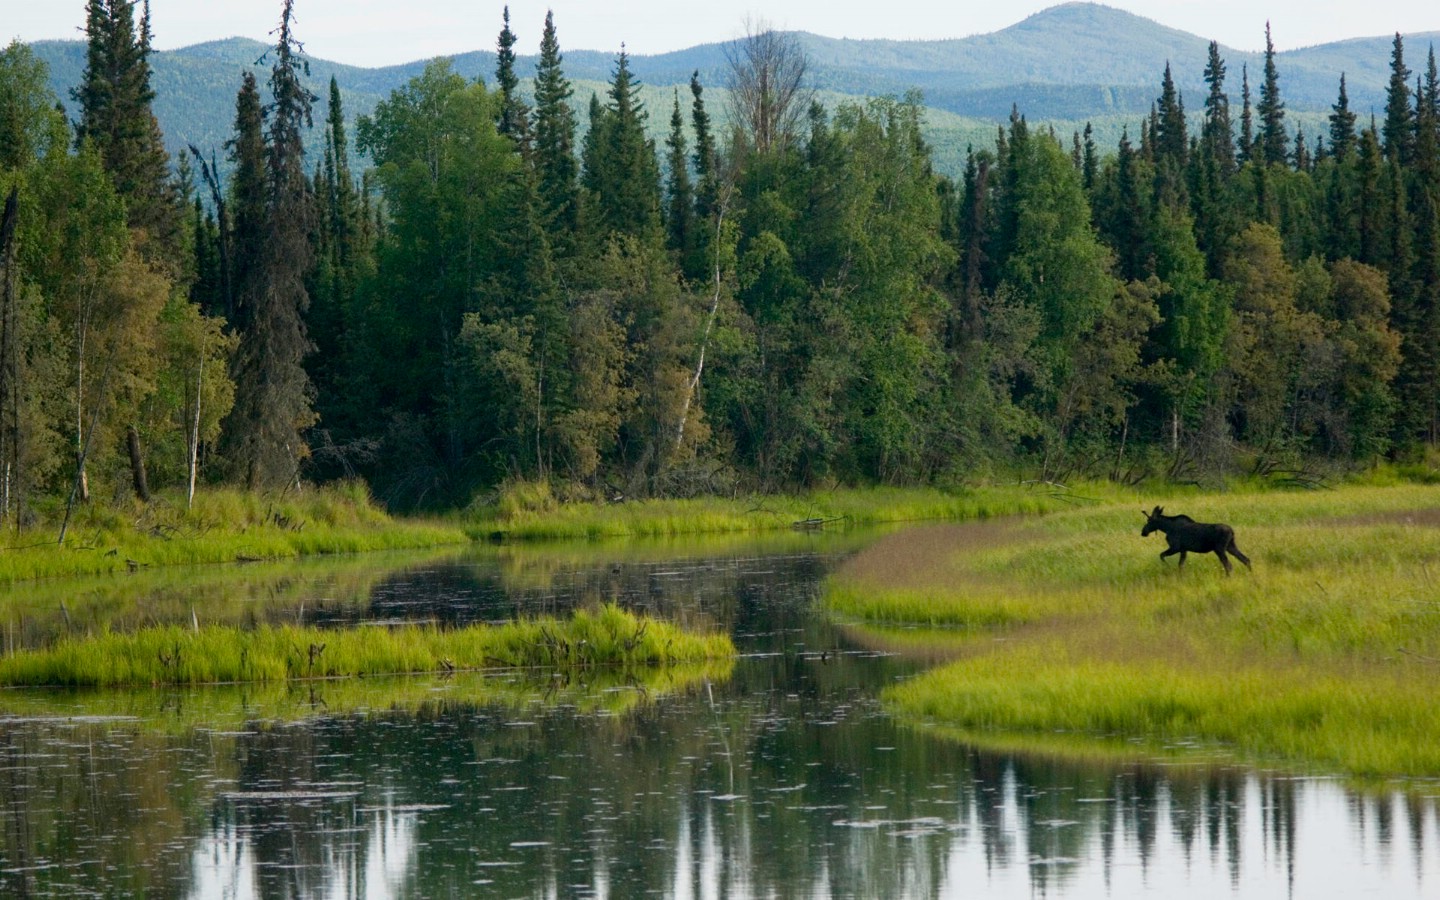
[0, 0, 1440, 66]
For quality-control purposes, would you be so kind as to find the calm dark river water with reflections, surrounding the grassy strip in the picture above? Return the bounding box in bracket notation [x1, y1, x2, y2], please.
[0, 541, 1440, 899]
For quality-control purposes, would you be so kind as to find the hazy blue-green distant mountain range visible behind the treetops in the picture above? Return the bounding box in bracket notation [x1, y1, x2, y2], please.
[32, 3, 1440, 179]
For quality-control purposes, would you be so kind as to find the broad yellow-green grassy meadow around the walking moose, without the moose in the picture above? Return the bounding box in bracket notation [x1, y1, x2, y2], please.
[827, 485, 1440, 778]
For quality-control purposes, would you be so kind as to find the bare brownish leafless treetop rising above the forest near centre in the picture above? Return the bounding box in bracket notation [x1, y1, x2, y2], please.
[726, 20, 815, 153]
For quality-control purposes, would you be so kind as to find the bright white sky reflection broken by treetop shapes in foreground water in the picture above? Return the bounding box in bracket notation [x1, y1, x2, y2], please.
[189, 772, 1440, 900]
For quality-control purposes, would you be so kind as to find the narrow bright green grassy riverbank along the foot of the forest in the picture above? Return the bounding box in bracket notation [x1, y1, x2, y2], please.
[0, 484, 1115, 585]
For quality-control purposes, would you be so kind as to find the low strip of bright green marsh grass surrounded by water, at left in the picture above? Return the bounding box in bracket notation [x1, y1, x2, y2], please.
[0, 606, 734, 687]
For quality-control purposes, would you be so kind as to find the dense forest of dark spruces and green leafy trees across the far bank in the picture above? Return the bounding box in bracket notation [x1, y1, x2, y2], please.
[0, 0, 1440, 512]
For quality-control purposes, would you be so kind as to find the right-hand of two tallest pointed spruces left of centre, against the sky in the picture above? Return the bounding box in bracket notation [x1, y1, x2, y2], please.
[534, 13, 580, 250]
